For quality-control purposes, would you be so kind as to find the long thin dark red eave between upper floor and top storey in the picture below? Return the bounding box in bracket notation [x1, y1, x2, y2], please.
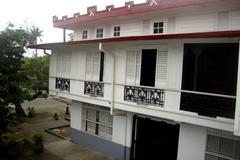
[28, 30, 240, 49]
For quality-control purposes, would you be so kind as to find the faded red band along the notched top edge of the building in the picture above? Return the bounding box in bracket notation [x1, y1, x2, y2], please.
[53, 0, 218, 28]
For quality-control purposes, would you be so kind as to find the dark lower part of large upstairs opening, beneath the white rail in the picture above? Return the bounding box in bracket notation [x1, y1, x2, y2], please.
[180, 93, 236, 118]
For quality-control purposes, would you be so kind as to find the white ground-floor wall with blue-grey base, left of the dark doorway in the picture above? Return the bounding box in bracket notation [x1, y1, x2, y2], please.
[70, 101, 132, 160]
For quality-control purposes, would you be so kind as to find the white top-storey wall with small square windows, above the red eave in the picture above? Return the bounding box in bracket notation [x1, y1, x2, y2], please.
[71, 5, 240, 40]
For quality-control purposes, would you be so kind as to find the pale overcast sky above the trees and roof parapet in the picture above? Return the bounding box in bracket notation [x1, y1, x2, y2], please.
[0, 0, 146, 43]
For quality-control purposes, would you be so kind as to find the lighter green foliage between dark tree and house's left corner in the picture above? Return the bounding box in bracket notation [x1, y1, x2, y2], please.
[22, 56, 48, 99]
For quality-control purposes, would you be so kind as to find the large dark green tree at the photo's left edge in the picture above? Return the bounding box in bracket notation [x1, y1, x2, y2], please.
[0, 25, 42, 119]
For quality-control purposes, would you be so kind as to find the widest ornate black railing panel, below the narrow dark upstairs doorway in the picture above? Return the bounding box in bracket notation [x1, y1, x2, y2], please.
[124, 86, 165, 107]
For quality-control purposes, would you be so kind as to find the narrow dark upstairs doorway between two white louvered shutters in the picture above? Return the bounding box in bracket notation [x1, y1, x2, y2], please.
[140, 49, 157, 87]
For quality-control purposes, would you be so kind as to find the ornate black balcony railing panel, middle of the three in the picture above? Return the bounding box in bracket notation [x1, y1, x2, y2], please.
[84, 81, 104, 97]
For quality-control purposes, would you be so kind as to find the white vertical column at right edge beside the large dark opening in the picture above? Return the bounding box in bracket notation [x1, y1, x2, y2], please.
[234, 41, 240, 136]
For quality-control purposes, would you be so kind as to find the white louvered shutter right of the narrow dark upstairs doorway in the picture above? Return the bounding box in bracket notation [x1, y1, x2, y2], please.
[155, 50, 168, 86]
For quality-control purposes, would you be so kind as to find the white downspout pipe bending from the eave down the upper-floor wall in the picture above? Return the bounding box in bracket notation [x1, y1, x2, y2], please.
[99, 42, 116, 115]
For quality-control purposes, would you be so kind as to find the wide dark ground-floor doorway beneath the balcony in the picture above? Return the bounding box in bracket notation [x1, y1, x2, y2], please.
[131, 116, 179, 160]
